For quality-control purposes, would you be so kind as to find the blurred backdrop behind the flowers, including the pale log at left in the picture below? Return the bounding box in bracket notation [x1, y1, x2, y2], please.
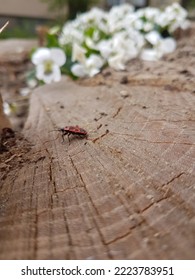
[0, 0, 195, 130]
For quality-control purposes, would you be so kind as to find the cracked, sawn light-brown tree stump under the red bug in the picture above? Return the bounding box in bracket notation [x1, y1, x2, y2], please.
[0, 29, 195, 259]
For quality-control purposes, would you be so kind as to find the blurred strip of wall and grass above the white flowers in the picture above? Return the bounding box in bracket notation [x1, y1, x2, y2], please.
[0, 0, 195, 39]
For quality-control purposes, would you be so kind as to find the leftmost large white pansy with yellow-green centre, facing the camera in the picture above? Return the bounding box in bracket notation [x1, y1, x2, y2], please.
[32, 48, 66, 84]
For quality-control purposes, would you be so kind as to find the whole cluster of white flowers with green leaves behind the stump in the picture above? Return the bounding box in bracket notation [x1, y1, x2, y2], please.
[32, 3, 189, 83]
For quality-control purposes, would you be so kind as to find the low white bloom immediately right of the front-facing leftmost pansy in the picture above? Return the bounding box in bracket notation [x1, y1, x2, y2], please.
[71, 54, 105, 77]
